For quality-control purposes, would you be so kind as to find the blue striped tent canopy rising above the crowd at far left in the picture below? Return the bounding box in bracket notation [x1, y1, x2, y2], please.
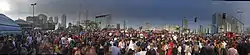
[0, 14, 21, 34]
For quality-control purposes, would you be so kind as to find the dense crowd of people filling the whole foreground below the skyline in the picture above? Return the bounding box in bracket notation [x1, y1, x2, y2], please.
[0, 31, 250, 55]
